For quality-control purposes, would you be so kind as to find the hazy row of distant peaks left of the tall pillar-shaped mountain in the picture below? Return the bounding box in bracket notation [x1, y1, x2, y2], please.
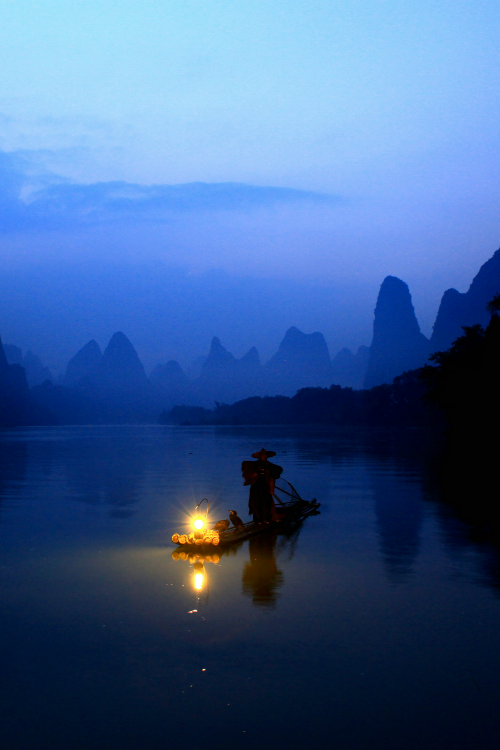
[31, 320, 368, 424]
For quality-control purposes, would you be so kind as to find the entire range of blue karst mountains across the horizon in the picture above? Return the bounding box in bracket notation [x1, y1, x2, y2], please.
[0, 250, 500, 424]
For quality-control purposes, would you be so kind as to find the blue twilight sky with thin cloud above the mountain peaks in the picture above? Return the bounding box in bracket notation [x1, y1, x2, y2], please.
[0, 0, 500, 368]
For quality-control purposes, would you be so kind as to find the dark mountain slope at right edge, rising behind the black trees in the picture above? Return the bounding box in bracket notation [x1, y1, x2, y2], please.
[430, 250, 500, 352]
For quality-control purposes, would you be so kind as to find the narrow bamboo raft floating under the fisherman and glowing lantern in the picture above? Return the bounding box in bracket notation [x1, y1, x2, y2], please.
[172, 479, 320, 551]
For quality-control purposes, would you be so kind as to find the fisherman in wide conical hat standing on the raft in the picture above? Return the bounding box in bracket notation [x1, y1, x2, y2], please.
[241, 448, 283, 524]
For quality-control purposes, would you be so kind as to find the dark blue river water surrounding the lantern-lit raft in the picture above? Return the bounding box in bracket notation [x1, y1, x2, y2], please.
[0, 426, 500, 750]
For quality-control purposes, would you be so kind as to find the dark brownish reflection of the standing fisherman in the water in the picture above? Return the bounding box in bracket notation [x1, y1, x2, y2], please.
[242, 531, 284, 608]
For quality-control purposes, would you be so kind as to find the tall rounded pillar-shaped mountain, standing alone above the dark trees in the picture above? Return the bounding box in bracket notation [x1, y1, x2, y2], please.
[364, 276, 429, 388]
